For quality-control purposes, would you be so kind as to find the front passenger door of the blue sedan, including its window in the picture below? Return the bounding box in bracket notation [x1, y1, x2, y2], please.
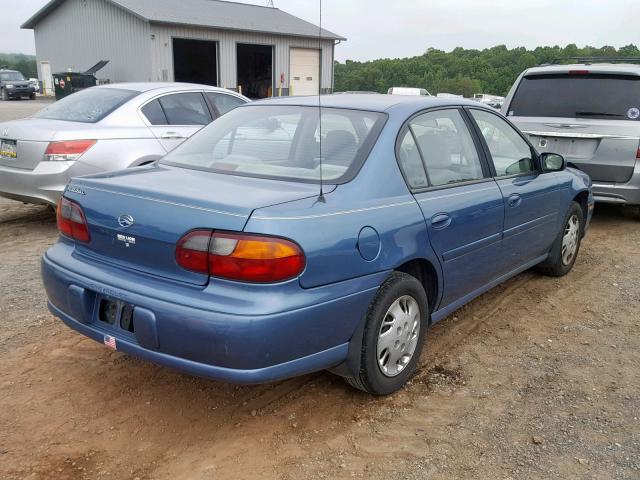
[469, 108, 564, 273]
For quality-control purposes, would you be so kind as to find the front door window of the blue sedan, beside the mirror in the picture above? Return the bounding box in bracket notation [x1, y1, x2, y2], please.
[471, 109, 536, 177]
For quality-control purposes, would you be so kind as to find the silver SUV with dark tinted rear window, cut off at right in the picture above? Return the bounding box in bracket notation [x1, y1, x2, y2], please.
[502, 58, 640, 212]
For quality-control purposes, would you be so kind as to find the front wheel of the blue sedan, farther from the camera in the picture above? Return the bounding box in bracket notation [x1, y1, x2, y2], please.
[536, 202, 584, 277]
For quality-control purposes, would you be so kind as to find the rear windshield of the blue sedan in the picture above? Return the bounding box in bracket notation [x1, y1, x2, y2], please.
[162, 105, 386, 183]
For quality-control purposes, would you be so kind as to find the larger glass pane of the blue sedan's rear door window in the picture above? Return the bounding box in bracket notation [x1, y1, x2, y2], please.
[409, 110, 484, 186]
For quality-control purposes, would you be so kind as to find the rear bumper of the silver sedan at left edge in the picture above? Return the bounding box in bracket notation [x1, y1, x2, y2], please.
[0, 161, 100, 205]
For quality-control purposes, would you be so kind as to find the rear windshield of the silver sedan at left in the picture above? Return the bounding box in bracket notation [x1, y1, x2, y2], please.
[34, 87, 139, 123]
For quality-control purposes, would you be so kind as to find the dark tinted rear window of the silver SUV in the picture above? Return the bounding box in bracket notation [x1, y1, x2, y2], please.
[509, 75, 640, 120]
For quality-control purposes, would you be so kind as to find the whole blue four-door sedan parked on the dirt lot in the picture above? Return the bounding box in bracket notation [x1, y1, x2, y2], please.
[42, 95, 593, 395]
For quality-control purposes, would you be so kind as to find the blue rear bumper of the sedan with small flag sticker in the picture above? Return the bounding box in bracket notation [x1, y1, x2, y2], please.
[42, 243, 387, 384]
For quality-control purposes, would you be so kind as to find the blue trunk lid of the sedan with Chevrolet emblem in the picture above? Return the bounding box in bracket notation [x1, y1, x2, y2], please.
[65, 166, 318, 285]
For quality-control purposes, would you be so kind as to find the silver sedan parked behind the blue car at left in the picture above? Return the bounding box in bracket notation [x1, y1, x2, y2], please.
[0, 83, 249, 205]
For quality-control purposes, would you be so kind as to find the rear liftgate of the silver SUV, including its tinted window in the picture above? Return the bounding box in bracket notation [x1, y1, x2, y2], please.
[507, 70, 640, 183]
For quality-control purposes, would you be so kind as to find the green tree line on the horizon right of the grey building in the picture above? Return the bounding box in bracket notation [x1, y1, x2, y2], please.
[335, 44, 640, 97]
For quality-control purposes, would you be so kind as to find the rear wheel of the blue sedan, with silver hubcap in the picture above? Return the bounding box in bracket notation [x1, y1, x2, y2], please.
[346, 272, 429, 395]
